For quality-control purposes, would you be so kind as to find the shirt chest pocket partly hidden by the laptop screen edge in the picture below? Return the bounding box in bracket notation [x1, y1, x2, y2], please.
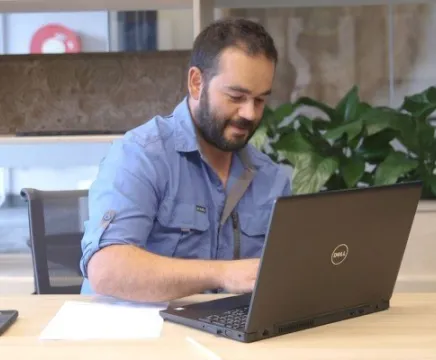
[238, 206, 271, 258]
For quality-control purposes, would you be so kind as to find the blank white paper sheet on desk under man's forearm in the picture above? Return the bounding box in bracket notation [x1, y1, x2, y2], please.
[40, 298, 167, 340]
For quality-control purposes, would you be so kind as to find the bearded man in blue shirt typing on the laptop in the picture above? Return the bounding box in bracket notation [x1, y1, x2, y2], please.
[81, 19, 290, 301]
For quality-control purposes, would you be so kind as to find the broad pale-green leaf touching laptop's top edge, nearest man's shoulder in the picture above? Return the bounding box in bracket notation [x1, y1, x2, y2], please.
[292, 152, 339, 194]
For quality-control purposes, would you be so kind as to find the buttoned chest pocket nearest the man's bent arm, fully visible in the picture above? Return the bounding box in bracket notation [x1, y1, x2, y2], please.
[147, 199, 212, 259]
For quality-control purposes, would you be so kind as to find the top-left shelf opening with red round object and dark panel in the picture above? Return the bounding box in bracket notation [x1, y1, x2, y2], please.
[0, 9, 193, 55]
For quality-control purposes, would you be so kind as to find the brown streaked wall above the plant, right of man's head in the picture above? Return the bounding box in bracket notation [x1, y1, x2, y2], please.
[231, 1, 436, 106]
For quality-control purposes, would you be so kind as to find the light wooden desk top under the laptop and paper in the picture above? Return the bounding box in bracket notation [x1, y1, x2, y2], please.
[0, 293, 436, 360]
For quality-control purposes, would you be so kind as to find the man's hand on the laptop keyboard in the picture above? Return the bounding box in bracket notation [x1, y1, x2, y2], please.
[220, 259, 259, 294]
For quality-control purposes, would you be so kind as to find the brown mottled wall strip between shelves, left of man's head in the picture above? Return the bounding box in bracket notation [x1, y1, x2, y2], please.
[0, 50, 189, 134]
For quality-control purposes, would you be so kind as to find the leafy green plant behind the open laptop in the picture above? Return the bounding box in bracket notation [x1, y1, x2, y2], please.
[252, 86, 436, 198]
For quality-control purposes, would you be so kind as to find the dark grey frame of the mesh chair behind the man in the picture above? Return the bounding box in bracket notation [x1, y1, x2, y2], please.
[20, 188, 88, 294]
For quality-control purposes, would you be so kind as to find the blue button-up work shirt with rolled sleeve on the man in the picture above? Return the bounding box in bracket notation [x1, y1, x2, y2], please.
[80, 98, 291, 294]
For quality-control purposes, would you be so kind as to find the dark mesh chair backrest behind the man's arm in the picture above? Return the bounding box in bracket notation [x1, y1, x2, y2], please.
[21, 188, 88, 294]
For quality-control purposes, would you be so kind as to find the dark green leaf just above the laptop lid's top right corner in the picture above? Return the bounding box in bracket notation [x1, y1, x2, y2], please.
[374, 151, 419, 185]
